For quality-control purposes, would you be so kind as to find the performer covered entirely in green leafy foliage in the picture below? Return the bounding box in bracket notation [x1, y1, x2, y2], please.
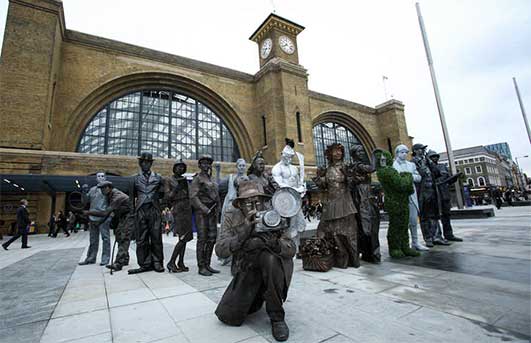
[376, 151, 420, 258]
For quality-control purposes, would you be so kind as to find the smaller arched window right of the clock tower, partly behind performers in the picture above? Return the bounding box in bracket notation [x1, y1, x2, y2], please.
[313, 122, 368, 166]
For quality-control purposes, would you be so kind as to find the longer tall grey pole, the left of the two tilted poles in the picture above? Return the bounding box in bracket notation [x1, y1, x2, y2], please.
[415, 2, 463, 209]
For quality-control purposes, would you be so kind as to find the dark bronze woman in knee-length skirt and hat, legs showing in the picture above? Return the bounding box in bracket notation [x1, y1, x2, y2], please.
[164, 160, 194, 273]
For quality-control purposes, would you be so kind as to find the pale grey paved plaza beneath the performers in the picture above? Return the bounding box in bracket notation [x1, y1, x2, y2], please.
[0, 207, 531, 343]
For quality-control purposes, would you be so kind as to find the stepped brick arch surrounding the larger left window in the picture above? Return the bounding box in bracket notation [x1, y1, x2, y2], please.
[65, 72, 252, 159]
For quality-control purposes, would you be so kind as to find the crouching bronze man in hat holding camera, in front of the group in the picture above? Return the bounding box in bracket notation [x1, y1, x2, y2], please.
[216, 181, 295, 341]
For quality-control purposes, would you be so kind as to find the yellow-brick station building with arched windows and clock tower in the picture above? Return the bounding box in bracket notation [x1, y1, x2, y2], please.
[0, 0, 411, 232]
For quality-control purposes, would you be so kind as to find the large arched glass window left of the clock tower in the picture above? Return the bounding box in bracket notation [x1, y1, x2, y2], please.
[77, 90, 240, 162]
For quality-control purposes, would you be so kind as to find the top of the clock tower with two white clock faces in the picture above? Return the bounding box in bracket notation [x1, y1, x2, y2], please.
[249, 13, 304, 67]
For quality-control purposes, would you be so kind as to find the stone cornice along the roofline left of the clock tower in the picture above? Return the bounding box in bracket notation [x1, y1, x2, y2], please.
[65, 30, 254, 82]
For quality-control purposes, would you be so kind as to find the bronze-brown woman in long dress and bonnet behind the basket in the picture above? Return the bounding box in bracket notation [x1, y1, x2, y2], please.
[313, 143, 360, 268]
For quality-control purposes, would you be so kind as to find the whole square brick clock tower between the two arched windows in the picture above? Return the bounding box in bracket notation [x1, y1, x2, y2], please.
[249, 13, 315, 165]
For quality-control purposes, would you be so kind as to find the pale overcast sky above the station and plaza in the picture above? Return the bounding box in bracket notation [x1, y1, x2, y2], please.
[0, 0, 531, 174]
